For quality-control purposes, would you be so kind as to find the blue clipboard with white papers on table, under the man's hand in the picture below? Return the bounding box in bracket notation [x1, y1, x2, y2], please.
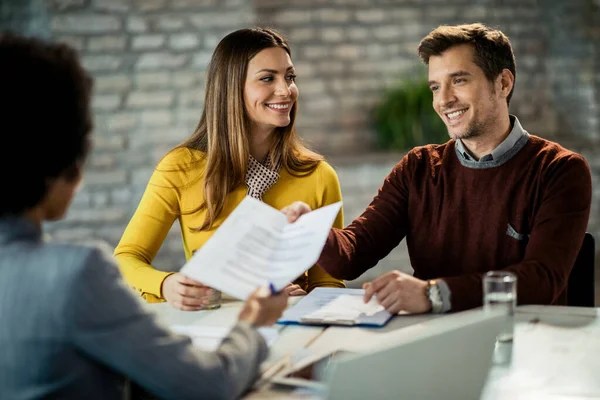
[278, 288, 392, 326]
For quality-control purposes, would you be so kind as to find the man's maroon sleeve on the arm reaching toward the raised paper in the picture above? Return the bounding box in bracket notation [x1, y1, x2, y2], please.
[318, 153, 411, 280]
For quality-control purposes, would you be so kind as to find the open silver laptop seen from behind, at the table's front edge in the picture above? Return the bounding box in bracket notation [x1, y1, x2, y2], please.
[275, 309, 508, 400]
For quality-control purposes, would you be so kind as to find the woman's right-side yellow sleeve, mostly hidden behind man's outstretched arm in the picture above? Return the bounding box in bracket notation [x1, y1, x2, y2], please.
[307, 162, 346, 292]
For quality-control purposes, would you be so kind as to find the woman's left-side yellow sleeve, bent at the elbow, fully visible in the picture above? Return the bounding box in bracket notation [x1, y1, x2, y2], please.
[115, 152, 182, 302]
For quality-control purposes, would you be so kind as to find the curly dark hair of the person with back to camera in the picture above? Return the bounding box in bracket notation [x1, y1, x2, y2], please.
[0, 33, 92, 215]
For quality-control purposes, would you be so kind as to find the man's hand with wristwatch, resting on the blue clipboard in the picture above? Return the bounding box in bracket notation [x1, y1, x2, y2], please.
[363, 271, 431, 314]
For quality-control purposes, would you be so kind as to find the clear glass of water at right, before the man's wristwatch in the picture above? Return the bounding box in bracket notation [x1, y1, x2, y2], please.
[483, 271, 517, 365]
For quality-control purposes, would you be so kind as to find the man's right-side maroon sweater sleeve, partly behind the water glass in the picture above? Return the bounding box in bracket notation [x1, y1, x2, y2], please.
[443, 154, 592, 311]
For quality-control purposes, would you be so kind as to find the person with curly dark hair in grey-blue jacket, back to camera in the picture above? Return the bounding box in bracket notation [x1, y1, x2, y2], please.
[0, 33, 287, 399]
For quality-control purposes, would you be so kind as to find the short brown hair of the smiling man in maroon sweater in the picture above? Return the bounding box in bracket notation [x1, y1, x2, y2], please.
[418, 23, 517, 104]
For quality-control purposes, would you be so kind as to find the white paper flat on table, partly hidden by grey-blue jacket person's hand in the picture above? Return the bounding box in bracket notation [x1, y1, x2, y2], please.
[171, 325, 279, 351]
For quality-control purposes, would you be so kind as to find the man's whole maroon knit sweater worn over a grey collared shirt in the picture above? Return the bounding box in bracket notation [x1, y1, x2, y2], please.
[319, 135, 592, 311]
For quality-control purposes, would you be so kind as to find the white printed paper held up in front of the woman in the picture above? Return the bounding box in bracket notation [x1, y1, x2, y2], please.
[181, 196, 342, 300]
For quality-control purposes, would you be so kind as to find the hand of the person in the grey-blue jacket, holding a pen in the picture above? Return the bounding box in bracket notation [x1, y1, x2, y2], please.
[238, 287, 288, 326]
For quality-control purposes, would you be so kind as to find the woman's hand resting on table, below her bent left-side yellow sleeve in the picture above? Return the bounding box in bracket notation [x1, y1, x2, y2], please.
[162, 272, 212, 311]
